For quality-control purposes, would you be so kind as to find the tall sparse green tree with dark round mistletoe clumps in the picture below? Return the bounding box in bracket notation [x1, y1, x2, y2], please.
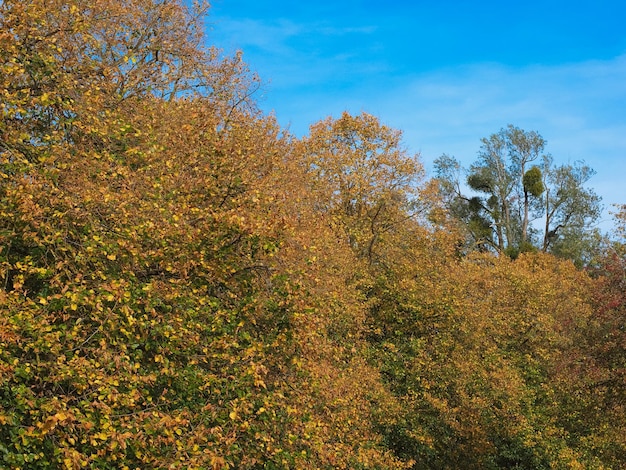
[435, 125, 600, 258]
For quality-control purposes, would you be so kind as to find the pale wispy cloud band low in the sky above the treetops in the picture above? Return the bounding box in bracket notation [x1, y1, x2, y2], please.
[254, 56, 626, 216]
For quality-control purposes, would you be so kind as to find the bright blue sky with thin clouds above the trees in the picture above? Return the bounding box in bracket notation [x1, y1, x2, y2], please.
[207, 0, 626, 228]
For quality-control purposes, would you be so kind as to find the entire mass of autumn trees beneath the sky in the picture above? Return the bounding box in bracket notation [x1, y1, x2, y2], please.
[0, 0, 626, 469]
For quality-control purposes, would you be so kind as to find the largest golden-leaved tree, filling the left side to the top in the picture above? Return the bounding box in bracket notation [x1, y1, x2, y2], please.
[0, 0, 414, 469]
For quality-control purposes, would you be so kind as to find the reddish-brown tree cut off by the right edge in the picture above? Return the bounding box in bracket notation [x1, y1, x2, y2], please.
[559, 205, 626, 468]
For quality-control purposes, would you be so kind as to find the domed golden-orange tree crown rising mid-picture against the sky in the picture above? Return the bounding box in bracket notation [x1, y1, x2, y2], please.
[303, 112, 423, 262]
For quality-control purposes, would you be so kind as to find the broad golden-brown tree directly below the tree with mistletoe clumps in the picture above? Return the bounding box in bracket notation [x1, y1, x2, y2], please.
[364, 246, 616, 469]
